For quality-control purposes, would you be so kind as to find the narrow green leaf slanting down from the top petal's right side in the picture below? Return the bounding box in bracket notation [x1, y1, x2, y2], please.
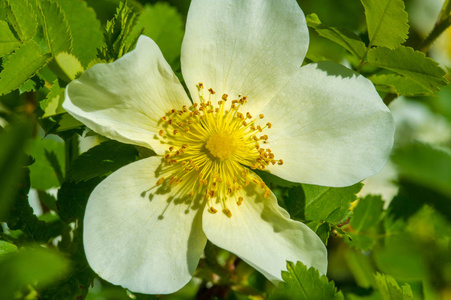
[306, 14, 366, 59]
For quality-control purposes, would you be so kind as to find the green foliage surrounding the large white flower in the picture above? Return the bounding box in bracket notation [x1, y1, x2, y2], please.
[0, 0, 451, 299]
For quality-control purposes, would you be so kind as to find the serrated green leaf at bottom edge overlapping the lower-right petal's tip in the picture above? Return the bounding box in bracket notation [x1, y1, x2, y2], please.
[270, 262, 344, 300]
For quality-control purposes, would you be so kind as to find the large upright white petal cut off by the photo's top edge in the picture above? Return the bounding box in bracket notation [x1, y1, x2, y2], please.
[181, 0, 309, 111]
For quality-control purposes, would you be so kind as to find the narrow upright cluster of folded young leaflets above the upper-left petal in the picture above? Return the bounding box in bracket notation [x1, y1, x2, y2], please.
[97, 1, 137, 61]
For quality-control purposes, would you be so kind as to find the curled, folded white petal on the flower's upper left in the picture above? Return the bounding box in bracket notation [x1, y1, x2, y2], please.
[63, 36, 190, 154]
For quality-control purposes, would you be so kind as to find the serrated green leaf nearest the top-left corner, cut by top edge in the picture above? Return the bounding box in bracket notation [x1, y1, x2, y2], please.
[6, 0, 38, 42]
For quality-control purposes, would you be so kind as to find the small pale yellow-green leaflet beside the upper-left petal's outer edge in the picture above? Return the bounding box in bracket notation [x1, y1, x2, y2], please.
[51, 51, 84, 83]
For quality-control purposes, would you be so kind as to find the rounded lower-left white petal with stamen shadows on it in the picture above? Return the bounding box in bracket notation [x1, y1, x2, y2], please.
[83, 157, 206, 294]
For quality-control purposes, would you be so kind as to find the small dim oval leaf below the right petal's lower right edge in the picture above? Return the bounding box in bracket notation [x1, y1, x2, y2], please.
[351, 195, 384, 232]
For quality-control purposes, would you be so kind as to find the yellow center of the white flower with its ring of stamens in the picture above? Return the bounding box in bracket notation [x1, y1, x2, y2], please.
[157, 83, 283, 217]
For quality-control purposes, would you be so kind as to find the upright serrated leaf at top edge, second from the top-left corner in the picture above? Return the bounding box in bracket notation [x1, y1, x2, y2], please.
[39, 0, 72, 55]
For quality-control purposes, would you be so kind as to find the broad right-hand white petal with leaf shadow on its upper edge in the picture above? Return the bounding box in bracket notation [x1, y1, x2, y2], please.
[262, 62, 394, 186]
